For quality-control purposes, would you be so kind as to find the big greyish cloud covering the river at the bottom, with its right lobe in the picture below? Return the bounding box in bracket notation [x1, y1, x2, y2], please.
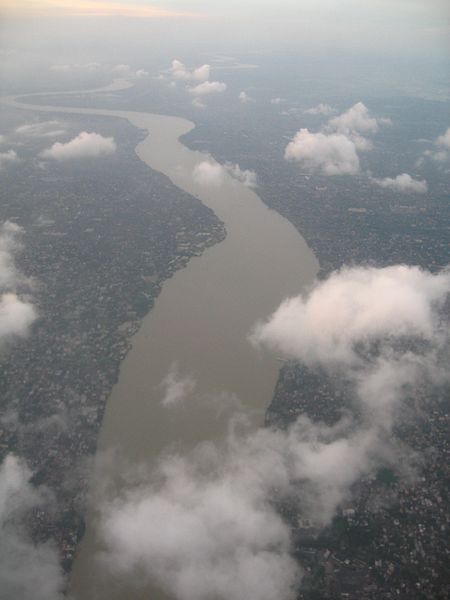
[99, 406, 400, 600]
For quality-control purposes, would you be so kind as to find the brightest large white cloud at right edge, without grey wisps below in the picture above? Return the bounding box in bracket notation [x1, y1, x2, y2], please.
[253, 265, 450, 367]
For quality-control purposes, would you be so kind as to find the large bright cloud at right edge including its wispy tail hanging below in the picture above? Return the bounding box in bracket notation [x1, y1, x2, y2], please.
[252, 265, 450, 442]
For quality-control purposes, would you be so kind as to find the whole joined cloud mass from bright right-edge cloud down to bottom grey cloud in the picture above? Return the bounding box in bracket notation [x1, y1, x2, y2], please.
[99, 265, 450, 600]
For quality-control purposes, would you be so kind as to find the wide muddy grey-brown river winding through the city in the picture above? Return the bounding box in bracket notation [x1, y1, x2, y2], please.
[5, 86, 319, 600]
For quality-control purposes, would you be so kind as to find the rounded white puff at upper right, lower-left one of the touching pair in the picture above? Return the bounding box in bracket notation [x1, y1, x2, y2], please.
[284, 129, 359, 175]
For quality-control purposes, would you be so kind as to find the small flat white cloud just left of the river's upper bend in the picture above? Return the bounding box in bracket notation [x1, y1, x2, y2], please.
[41, 131, 117, 161]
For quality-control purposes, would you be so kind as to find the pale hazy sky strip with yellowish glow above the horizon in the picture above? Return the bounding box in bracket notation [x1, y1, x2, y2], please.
[0, 0, 450, 59]
